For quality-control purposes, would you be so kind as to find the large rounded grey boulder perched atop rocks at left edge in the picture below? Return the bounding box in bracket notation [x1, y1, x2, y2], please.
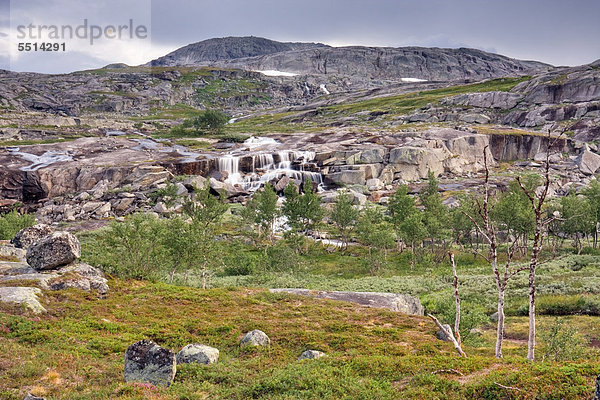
[27, 232, 81, 270]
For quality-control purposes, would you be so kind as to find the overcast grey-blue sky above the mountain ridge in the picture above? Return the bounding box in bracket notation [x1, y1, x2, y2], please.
[0, 0, 600, 73]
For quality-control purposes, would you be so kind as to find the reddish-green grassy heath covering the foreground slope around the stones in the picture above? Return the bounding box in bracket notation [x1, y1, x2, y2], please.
[0, 279, 600, 400]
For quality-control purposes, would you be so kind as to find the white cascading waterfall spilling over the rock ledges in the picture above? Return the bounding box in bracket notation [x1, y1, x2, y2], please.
[217, 138, 323, 192]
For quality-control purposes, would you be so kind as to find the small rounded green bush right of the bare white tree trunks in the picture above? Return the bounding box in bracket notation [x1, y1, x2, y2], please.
[540, 318, 586, 361]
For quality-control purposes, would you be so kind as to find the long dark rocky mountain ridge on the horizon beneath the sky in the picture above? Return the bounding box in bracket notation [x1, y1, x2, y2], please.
[148, 37, 552, 81]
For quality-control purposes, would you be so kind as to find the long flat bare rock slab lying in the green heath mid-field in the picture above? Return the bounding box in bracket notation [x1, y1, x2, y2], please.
[269, 289, 425, 315]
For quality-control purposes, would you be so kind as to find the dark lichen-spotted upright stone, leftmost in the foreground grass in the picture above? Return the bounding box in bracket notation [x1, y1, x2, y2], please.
[124, 340, 177, 386]
